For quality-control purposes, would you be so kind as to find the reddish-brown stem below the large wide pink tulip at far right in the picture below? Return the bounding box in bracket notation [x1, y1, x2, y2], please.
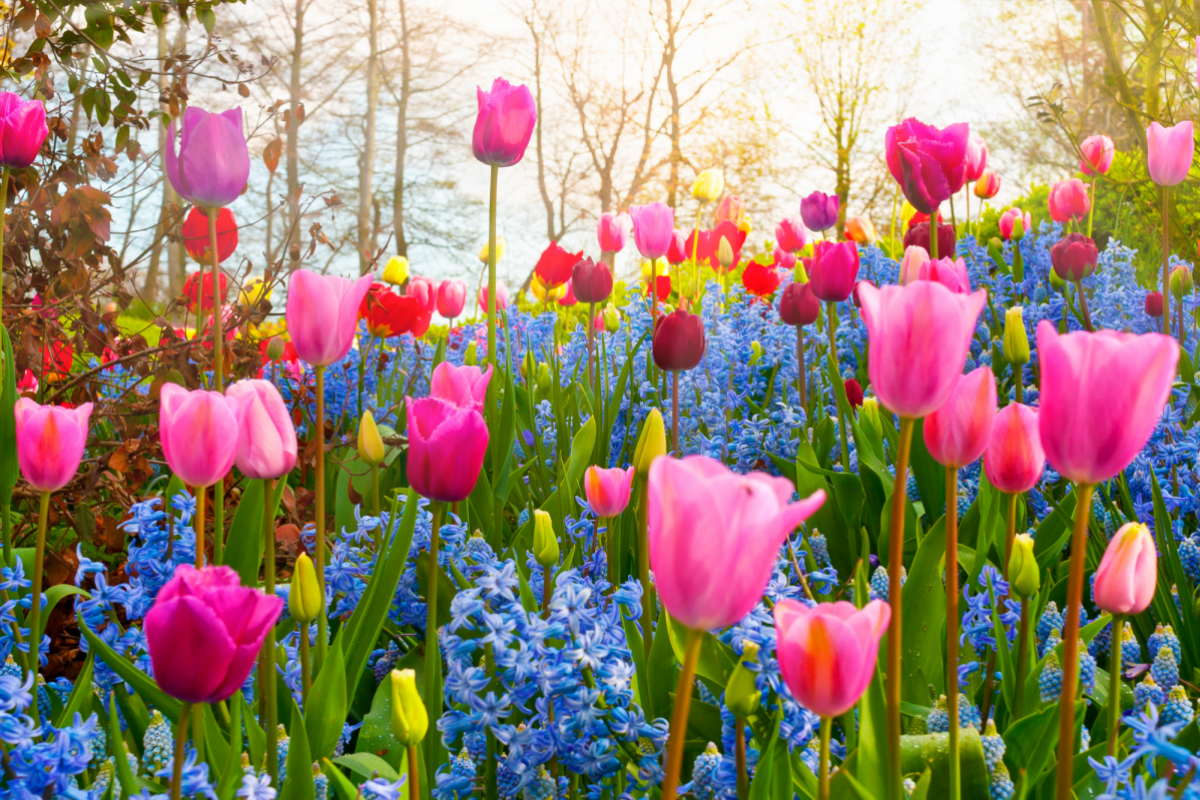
[1055, 483, 1094, 800]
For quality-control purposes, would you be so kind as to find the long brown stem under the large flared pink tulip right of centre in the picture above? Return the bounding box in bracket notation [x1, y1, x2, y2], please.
[887, 416, 917, 800]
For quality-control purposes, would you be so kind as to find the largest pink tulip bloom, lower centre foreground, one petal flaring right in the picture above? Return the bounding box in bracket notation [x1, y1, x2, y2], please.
[648, 456, 824, 631]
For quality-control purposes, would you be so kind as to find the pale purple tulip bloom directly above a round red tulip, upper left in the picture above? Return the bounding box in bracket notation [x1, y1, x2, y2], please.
[167, 106, 250, 209]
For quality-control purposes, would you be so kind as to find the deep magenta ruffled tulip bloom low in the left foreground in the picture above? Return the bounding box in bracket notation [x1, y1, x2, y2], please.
[143, 565, 283, 703]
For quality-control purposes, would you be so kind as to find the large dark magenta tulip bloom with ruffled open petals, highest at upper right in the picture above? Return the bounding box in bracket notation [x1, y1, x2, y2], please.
[883, 118, 971, 214]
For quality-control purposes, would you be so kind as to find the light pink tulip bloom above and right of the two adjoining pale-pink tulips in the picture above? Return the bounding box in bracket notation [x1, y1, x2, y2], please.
[286, 270, 374, 367]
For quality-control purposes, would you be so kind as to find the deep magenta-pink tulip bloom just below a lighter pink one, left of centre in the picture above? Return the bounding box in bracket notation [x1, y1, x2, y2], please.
[404, 397, 487, 503]
